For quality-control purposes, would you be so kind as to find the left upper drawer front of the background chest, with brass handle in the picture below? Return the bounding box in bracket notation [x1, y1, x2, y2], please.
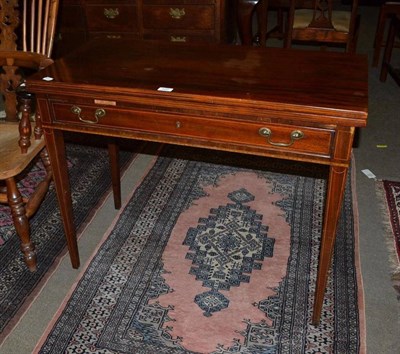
[86, 4, 138, 32]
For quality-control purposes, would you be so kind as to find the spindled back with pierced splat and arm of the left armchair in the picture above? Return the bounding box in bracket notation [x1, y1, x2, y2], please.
[0, 0, 58, 121]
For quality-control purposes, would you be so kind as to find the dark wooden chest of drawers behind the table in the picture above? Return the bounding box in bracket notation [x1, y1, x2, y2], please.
[57, 0, 235, 57]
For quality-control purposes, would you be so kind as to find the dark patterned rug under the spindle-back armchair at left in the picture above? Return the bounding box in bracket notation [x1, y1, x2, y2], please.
[0, 144, 133, 343]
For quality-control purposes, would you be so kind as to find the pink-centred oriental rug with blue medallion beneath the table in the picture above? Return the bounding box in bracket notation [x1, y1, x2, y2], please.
[35, 147, 365, 354]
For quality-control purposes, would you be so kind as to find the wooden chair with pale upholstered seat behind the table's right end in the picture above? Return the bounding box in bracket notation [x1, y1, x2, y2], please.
[285, 0, 359, 53]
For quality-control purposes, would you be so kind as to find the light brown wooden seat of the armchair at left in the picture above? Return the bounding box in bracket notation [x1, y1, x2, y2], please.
[0, 122, 45, 180]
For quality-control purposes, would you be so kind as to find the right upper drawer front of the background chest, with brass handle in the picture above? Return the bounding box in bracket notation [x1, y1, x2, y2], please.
[143, 5, 215, 30]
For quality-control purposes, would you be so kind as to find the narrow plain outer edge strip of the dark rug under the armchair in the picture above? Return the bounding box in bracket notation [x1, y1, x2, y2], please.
[0, 147, 140, 346]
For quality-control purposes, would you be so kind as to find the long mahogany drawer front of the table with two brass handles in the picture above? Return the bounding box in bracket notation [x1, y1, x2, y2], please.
[52, 103, 334, 157]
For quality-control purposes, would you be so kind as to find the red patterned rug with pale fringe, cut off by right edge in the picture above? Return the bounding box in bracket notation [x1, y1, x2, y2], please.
[378, 181, 400, 299]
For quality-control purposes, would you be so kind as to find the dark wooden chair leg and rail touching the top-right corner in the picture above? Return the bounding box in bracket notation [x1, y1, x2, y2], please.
[372, 1, 400, 67]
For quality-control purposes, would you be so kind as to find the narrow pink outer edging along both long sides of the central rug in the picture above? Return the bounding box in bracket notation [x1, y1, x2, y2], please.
[32, 152, 367, 354]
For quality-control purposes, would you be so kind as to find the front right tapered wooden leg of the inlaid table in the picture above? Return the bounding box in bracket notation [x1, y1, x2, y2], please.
[312, 166, 348, 325]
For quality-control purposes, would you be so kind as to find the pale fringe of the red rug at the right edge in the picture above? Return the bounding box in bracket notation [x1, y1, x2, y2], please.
[376, 180, 400, 299]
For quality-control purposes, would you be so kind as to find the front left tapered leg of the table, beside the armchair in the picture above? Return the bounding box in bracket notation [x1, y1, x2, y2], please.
[44, 128, 80, 268]
